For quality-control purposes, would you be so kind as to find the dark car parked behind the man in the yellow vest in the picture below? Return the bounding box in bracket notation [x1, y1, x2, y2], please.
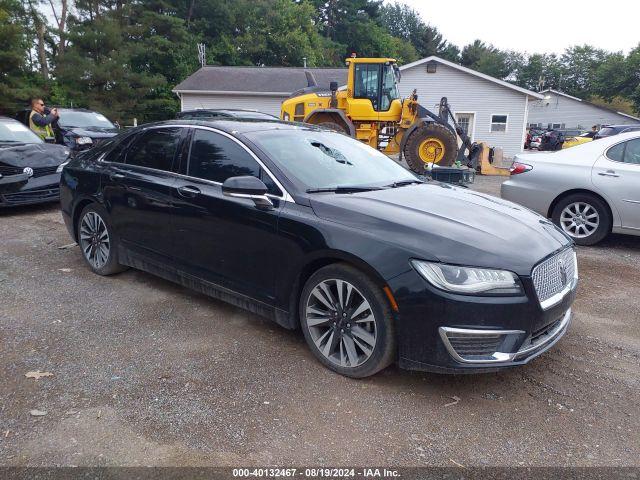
[16, 108, 118, 152]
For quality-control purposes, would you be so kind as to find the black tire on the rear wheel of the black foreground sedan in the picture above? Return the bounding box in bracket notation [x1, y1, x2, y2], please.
[76, 203, 128, 275]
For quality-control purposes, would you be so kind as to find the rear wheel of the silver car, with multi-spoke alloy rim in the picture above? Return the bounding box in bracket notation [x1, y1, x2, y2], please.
[551, 193, 612, 245]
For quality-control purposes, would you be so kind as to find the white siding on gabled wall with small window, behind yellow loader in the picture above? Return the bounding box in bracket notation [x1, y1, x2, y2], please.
[400, 63, 527, 157]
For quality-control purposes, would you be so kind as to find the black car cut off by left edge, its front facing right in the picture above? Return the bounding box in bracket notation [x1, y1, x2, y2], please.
[0, 117, 69, 207]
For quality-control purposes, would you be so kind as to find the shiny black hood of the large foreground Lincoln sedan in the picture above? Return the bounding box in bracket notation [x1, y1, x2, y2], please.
[311, 182, 572, 275]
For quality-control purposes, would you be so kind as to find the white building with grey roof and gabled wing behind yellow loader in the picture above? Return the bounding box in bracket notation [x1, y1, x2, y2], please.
[173, 57, 544, 157]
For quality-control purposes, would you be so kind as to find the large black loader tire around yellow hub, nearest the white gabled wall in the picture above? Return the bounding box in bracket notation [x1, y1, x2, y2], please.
[403, 123, 458, 174]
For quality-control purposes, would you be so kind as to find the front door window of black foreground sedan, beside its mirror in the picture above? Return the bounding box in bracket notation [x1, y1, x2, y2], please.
[187, 129, 282, 195]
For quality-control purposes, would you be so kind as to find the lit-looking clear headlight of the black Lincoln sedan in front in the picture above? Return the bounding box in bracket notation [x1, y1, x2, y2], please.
[411, 260, 523, 295]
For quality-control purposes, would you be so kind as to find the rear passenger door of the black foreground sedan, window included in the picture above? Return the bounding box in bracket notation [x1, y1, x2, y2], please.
[102, 127, 188, 256]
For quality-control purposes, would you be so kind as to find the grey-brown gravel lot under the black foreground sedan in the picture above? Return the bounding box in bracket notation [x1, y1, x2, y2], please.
[0, 178, 640, 467]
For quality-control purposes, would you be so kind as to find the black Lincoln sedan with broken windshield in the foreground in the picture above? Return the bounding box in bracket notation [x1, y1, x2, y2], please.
[60, 120, 578, 377]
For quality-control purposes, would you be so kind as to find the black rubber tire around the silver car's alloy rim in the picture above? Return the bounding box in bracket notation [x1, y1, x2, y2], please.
[551, 193, 613, 245]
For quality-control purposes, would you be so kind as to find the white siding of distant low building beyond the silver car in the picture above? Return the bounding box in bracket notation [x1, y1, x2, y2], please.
[527, 92, 640, 130]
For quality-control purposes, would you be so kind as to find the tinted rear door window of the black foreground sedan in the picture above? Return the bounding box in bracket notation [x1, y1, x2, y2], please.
[125, 128, 181, 171]
